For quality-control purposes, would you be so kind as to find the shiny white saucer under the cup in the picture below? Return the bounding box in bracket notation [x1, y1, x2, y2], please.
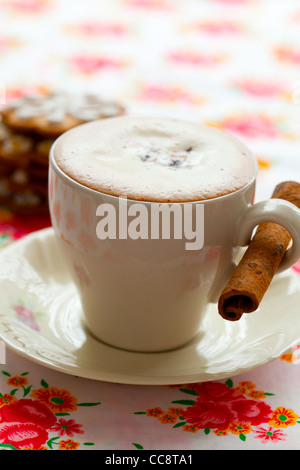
[0, 228, 300, 385]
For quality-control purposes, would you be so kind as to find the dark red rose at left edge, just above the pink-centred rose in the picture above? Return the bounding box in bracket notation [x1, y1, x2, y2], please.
[0, 398, 56, 429]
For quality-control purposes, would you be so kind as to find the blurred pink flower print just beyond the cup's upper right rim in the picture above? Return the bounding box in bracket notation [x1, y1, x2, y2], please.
[221, 115, 278, 139]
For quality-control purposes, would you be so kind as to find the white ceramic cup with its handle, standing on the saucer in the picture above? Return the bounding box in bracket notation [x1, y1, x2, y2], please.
[49, 123, 300, 352]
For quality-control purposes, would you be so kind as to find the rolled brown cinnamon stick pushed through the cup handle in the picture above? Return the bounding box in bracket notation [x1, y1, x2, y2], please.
[218, 181, 300, 321]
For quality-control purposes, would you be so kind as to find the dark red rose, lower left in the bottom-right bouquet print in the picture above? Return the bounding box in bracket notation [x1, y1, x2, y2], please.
[183, 402, 235, 430]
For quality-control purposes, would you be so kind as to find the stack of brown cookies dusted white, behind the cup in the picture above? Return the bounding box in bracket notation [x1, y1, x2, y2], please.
[0, 93, 125, 214]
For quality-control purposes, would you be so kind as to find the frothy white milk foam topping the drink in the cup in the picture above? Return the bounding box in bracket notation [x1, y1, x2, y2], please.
[53, 116, 255, 202]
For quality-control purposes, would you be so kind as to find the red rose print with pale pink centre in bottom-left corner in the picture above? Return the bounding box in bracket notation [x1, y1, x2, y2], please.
[0, 422, 48, 450]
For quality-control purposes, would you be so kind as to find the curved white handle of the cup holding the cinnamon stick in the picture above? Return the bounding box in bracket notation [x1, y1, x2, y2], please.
[233, 199, 300, 273]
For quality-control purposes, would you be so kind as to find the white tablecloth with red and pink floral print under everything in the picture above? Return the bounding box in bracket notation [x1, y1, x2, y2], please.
[0, 0, 300, 452]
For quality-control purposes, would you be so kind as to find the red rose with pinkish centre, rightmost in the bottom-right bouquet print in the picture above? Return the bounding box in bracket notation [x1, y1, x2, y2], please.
[231, 398, 272, 426]
